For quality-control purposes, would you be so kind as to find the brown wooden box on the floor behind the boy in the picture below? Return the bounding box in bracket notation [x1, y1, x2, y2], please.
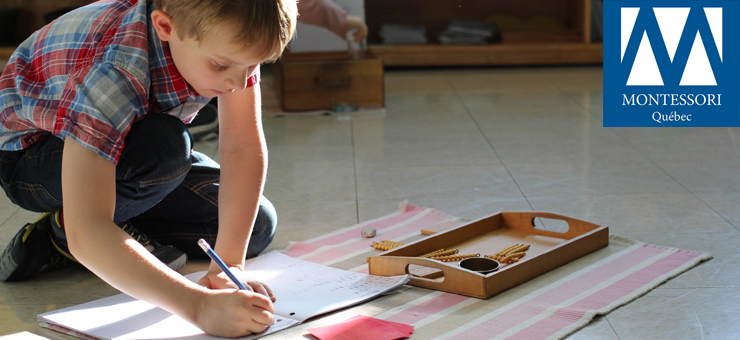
[273, 51, 385, 111]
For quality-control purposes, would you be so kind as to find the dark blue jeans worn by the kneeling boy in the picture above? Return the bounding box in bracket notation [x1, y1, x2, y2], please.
[0, 113, 277, 259]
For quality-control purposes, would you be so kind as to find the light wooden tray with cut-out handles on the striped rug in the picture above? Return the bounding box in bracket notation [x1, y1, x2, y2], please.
[369, 212, 609, 299]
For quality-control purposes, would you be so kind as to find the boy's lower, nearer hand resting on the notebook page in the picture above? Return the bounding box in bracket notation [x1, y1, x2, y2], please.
[196, 289, 275, 338]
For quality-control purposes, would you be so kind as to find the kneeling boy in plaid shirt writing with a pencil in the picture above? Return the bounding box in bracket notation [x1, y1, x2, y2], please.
[0, 0, 296, 337]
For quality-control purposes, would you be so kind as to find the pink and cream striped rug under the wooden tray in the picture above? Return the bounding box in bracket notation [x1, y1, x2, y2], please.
[263, 204, 711, 339]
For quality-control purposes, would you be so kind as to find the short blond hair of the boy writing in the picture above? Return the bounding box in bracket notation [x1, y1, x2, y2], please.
[154, 0, 298, 60]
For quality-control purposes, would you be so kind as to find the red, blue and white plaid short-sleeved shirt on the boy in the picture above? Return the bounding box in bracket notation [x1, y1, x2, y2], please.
[0, 0, 259, 164]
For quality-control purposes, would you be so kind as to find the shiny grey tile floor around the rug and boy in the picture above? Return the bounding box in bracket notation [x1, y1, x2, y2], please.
[0, 66, 740, 339]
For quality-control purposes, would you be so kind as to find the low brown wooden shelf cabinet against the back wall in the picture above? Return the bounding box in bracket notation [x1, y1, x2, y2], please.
[365, 0, 603, 66]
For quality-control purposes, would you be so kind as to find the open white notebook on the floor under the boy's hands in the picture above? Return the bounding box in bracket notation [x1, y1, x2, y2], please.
[38, 251, 408, 340]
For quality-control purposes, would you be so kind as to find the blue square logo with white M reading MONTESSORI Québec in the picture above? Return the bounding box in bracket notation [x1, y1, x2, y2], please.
[604, 0, 740, 127]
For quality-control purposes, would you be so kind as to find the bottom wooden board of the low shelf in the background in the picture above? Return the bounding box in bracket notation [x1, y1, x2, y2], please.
[369, 43, 603, 66]
